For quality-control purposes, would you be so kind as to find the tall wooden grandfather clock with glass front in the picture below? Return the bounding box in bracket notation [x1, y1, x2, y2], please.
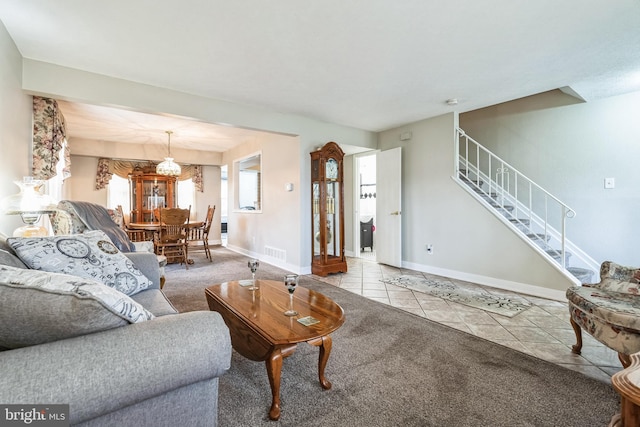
[311, 142, 347, 276]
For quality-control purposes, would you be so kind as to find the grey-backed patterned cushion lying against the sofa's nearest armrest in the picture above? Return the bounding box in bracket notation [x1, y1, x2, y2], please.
[0, 266, 154, 348]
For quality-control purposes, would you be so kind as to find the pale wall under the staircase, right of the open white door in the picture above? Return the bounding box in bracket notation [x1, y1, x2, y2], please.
[378, 114, 571, 298]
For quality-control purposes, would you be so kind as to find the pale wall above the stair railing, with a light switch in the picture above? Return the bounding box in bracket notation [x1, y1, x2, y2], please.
[460, 91, 640, 265]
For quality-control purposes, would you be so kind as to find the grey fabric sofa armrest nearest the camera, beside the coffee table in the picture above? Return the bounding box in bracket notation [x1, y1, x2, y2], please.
[0, 311, 231, 424]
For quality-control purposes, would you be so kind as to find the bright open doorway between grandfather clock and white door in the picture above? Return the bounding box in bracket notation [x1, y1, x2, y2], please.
[356, 153, 376, 261]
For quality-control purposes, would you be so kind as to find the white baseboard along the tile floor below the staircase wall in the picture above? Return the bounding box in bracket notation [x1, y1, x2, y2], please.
[402, 262, 567, 302]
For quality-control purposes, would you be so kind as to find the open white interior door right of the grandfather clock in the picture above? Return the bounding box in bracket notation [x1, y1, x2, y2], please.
[375, 147, 402, 267]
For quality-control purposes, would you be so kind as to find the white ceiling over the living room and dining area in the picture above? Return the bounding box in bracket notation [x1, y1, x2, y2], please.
[0, 0, 640, 151]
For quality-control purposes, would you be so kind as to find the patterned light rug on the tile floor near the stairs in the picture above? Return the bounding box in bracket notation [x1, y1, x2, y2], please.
[382, 275, 531, 317]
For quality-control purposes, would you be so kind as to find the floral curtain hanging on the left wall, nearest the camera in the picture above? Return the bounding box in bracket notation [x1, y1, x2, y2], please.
[32, 96, 71, 180]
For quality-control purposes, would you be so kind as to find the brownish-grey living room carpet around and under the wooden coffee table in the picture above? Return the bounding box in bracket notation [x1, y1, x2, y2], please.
[165, 249, 620, 427]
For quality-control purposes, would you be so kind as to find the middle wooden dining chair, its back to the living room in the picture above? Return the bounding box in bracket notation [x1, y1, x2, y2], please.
[155, 208, 190, 270]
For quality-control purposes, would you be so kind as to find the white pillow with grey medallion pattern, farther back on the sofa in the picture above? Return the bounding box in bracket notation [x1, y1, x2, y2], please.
[7, 230, 152, 295]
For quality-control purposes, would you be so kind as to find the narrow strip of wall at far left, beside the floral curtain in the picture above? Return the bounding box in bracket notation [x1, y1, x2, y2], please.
[0, 21, 33, 235]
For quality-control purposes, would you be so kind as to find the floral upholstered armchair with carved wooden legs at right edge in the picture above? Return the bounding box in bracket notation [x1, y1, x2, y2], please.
[566, 261, 640, 368]
